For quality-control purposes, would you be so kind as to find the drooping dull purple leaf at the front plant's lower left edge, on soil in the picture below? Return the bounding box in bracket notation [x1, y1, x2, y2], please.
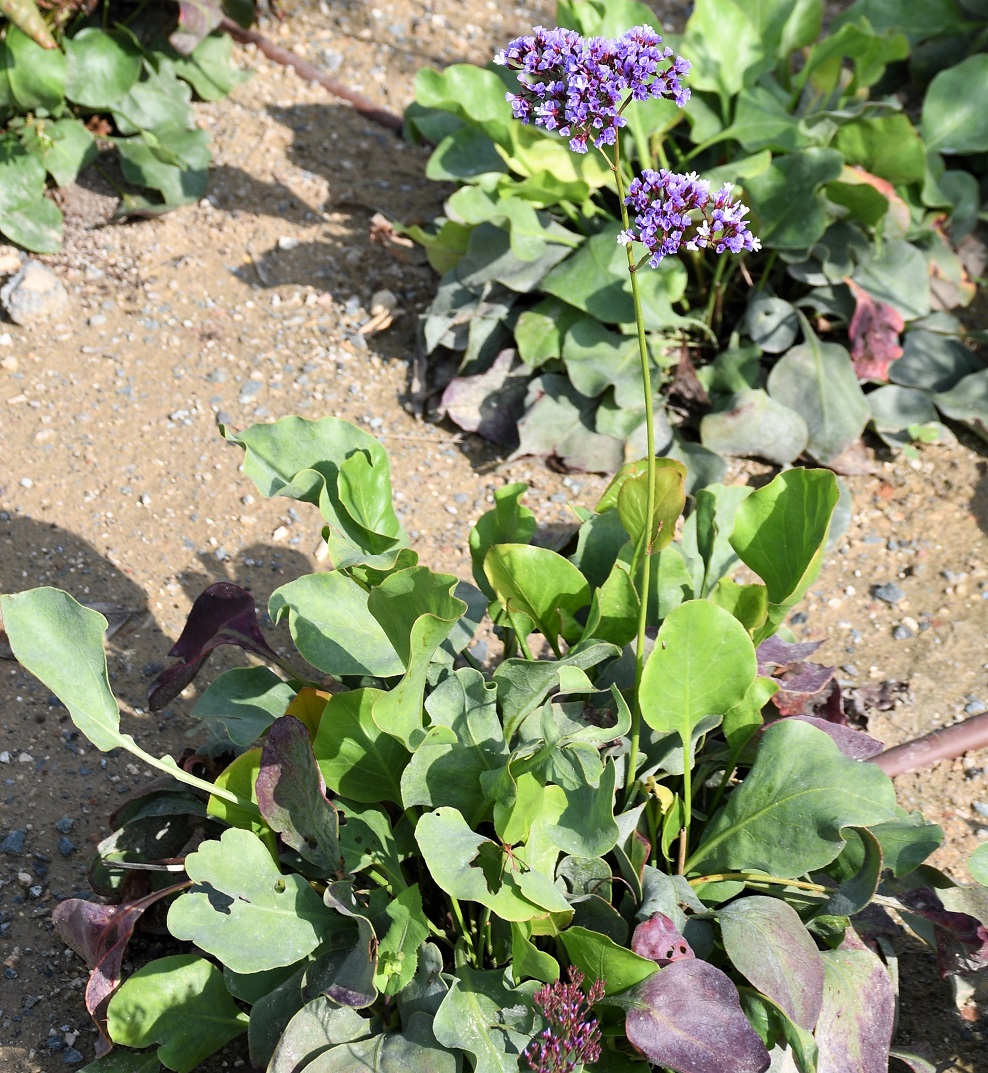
[51, 882, 189, 1058]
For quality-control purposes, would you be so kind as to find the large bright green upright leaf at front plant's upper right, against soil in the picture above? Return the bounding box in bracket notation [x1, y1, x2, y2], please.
[731, 469, 840, 642]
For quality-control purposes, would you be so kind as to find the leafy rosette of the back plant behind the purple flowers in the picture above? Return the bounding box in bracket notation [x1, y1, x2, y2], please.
[405, 0, 988, 480]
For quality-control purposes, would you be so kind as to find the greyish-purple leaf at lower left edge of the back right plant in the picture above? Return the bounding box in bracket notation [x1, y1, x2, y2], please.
[440, 350, 531, 447]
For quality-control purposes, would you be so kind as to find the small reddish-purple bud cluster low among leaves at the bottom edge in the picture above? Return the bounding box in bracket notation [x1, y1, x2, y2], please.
[525, 966, 604, 1073]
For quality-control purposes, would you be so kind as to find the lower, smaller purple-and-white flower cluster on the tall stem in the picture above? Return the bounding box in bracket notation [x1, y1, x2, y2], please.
[618, 168, 762, 268]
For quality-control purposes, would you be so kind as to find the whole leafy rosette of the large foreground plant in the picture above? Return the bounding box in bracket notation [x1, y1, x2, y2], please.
[0, 409, 988, 1073]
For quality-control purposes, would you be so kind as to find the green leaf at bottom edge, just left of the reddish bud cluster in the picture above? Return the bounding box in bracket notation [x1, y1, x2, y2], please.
[432, 965, 537, 1073]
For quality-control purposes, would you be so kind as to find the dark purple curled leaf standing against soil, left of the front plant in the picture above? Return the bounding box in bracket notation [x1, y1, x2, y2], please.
[148, 582, 276, 711]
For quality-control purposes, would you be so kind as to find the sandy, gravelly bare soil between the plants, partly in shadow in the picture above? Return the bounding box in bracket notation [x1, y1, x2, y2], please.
[0, 0, 988, 1073]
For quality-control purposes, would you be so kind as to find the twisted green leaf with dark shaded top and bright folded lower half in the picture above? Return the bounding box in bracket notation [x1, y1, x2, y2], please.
[367, 567, 467, 749]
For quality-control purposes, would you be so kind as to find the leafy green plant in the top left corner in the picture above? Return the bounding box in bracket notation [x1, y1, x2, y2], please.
[0, 0, 253, 253]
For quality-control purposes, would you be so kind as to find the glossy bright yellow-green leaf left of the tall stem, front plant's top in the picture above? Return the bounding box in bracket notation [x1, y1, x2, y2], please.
[484, 544, 590, 648]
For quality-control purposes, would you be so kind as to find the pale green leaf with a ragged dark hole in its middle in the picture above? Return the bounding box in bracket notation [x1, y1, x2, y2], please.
[415, 807, 571, 921]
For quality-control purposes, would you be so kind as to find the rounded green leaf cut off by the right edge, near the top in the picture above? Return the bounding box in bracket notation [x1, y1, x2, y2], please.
[920, 53, 988, 152]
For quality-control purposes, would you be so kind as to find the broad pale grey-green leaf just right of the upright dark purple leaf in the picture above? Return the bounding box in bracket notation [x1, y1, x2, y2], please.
[268, 571, 402, 678]
